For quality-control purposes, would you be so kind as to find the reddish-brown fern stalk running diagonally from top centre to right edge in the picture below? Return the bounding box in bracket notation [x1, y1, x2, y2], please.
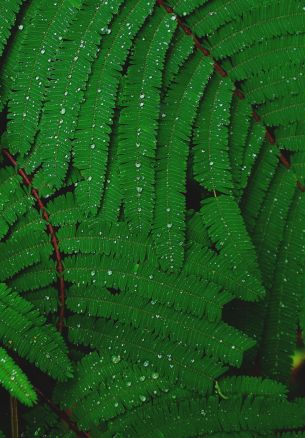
[157, 0, 305, 192]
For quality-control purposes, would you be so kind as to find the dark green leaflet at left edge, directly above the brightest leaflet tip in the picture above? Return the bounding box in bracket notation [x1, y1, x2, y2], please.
[0, 284, 71, 380]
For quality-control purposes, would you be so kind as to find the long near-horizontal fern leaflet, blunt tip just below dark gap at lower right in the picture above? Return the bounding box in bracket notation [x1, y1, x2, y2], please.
[67, 282, 254, 366]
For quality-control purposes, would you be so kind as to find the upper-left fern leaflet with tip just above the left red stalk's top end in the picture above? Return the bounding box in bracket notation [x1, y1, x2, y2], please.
[5, 0, 77, 156]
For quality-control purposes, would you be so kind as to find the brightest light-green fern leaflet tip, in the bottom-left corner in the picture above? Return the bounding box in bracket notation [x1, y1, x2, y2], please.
[0, 347, 37, 406]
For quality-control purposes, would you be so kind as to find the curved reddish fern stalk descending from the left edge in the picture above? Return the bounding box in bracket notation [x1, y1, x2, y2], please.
[2, 149, 65, 333]
